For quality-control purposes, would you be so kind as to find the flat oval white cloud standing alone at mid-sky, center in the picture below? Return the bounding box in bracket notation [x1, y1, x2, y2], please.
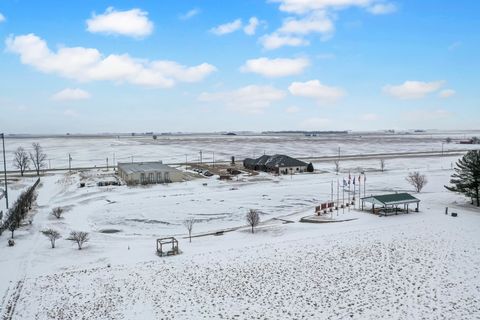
[240, 57, 310, 78]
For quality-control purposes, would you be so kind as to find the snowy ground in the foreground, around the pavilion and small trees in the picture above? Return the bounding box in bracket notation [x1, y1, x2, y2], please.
[0, 153, 480, 319]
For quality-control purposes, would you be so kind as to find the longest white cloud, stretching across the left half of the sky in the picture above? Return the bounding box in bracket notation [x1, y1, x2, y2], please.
[6, 34, 216, 88]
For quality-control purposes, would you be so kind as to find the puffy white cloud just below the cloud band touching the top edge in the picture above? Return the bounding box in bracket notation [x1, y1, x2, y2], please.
[278, 11, 335, 35]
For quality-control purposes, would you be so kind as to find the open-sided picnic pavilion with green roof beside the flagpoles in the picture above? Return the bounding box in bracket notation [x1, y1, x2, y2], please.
[360, 193, 420, 215]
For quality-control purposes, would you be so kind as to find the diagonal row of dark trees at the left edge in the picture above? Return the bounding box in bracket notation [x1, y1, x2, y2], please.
[0, 179, 40, 239]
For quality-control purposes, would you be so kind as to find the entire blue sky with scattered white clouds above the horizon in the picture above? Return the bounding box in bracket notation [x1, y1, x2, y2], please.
[0, 0, 480, 133]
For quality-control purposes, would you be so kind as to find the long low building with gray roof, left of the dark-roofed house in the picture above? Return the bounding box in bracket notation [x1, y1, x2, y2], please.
[118, 161, 184, 184]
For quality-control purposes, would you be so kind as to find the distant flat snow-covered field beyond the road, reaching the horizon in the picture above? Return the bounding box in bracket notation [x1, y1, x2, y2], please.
[6, 131, 480, 169]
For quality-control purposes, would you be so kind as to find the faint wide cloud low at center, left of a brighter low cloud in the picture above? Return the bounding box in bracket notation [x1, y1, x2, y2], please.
[198, 85, 286, 114]
